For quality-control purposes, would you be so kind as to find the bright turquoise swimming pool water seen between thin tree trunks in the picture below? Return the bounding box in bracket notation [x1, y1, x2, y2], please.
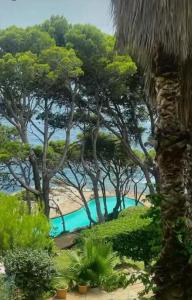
[50, 197, 141, 237]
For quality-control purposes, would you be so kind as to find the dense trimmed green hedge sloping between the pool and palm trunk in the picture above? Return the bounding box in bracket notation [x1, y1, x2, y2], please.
[82, 207, 158, 264]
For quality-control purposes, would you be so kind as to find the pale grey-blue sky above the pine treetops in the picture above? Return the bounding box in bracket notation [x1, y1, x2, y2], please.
[0, 0, 113, 34]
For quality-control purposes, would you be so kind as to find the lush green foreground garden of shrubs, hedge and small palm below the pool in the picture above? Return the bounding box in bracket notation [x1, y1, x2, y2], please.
[0, 194, 160, 300]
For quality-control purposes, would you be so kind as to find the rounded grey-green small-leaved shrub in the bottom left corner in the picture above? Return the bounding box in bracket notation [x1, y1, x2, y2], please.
[4, 249, 55, 300]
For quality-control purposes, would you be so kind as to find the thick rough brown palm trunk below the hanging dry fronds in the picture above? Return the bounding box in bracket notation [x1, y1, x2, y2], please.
[155, 49, 192, 300]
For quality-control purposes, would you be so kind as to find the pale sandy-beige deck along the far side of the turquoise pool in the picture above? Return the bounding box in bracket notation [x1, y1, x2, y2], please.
[50, 187, 148, 218]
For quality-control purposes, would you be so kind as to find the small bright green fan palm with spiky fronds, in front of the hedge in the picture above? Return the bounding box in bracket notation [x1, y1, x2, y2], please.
[67, 239, 116, 286]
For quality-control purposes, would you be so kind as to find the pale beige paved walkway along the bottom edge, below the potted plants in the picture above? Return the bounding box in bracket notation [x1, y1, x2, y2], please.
[49, 284, 143, 300]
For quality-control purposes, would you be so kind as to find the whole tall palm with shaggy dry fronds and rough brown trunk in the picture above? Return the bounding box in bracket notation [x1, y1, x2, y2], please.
[111, 0, 192, 300]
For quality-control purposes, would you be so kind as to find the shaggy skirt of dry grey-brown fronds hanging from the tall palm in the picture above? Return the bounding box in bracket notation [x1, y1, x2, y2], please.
[111, 0, 192, 126]
